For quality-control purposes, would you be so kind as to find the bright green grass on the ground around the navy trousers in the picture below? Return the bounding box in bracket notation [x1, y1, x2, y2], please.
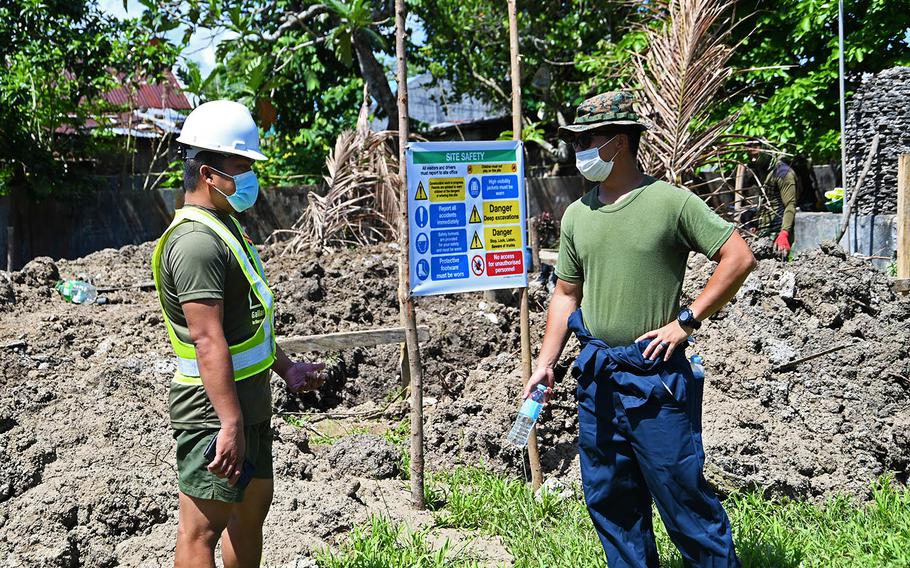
[320, 469, 910, 568]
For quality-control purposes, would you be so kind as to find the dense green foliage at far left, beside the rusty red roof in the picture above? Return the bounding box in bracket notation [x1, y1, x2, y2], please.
[0, 0, 177, 193]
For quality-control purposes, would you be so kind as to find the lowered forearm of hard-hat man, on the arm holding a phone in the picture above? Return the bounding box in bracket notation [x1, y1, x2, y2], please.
[196, 336, 243, 428]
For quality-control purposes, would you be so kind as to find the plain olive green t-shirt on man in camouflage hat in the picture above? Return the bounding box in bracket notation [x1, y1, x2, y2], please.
[556, 177, 733, 346]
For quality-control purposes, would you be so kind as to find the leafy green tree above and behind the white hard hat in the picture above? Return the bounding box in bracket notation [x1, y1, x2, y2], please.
[153, 0, 398, 183]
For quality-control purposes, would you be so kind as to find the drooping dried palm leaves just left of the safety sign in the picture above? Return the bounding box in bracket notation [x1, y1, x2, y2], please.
[273, 100, 400, 252]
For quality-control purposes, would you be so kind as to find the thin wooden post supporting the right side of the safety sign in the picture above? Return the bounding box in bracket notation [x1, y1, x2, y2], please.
[509, 0, 543, 489]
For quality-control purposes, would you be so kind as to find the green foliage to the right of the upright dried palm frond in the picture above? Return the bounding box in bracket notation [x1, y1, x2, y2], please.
[721, 0, 910, 161]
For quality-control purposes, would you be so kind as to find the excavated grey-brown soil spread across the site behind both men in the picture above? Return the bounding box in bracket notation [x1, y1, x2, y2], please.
[0, 237, 910, 567]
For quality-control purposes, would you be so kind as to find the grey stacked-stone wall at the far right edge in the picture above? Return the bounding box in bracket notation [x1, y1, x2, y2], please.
[846, 67, 910, 215]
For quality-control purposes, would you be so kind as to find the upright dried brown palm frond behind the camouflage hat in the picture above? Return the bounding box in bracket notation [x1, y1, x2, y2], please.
[634, 0, 737, 185]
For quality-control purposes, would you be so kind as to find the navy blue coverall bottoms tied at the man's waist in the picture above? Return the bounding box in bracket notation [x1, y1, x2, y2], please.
[570, 312, 740, 568]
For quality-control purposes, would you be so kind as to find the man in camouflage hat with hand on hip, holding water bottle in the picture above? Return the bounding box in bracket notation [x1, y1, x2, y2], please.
[525, 91, 755, 568]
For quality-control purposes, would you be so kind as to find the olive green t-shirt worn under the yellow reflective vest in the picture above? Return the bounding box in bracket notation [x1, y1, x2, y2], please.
[161, 205, 272, 430]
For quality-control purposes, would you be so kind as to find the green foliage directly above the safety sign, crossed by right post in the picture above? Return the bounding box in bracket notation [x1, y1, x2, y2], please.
[412, 0, 638, 131]
